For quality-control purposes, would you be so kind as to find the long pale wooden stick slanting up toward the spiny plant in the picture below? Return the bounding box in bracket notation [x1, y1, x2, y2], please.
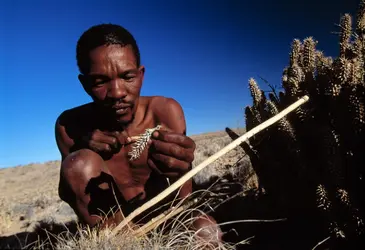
[111, 95, 309, 236]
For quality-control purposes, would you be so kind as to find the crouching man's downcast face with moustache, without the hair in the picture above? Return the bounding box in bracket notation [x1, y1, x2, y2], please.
[79, 45, 144, 124]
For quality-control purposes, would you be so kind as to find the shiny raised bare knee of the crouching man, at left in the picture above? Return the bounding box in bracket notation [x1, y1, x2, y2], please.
[58, 149, 104, 201]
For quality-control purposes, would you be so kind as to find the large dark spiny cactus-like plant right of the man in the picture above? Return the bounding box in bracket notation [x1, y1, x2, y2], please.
[240, 0, 365, 247]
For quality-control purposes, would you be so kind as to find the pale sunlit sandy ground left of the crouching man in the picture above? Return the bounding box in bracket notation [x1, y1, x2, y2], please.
[0, 161, 76, 236]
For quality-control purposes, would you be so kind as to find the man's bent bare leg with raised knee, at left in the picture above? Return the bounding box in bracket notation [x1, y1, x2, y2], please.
[59, 149, 123, 226]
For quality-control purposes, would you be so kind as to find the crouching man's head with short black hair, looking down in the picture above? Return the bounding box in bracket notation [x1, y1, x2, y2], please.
[76, 24, 144, 124]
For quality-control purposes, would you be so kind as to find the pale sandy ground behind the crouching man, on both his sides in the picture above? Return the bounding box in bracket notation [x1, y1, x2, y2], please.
[0, 130, 253, 239]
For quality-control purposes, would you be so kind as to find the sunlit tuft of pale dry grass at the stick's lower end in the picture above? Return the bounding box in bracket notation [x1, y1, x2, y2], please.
[47, 203, 248, 250]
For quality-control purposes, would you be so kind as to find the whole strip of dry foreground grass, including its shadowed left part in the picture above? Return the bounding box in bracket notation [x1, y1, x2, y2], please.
[2, 188, 250, 250]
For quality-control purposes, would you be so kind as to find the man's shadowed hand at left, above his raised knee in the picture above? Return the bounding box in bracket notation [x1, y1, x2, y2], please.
[83, 129, 130, 153]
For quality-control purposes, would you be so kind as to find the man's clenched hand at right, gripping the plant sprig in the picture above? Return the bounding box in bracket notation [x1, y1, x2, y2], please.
[148, 130, 195, 178]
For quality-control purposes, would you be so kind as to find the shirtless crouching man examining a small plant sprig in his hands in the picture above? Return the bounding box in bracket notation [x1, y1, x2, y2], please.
[55, 24, 222, 240]
